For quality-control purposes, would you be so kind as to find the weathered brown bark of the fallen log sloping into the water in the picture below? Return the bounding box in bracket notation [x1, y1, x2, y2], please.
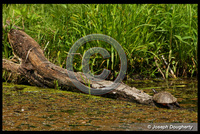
[3, 29, 152, 104]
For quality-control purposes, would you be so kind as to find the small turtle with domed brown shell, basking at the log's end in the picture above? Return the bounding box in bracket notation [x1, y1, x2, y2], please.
[152, 89, 180, 109]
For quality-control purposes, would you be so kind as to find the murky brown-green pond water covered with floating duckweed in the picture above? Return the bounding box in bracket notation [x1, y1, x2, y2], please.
[2, 79, 197, 131]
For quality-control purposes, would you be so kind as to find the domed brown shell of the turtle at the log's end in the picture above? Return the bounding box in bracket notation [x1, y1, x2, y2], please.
[153, 91, 177, 103]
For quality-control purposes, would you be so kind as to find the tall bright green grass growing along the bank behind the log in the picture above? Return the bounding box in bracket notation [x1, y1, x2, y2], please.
[2, 4, 198, 77]
